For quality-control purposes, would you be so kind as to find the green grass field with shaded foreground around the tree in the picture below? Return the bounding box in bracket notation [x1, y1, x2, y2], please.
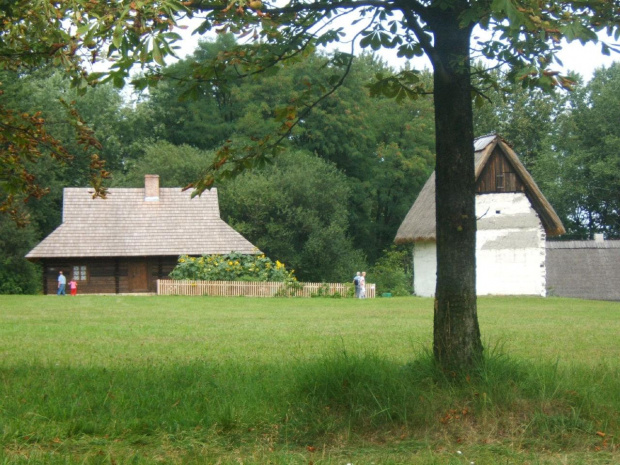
[0, 296, 620, 464]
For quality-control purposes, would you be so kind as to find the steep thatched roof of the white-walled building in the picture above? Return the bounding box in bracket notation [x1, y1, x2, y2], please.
[394, 134, 565, 244]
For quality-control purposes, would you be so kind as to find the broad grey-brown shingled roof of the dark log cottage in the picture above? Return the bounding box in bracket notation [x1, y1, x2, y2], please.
[26, 176, 258, 259]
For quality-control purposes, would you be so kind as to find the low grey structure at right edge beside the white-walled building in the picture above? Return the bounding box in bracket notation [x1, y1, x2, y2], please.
[545, 241, 620, 300]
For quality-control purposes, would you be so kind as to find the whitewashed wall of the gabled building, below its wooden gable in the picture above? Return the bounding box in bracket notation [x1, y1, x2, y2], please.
[413, 193, 546, 297]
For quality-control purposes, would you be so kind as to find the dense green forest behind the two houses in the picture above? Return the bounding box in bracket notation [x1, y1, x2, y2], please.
[0, 35, 620, 294]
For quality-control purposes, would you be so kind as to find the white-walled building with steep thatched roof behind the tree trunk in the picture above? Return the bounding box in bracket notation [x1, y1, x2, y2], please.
[395, 135, 565, 296]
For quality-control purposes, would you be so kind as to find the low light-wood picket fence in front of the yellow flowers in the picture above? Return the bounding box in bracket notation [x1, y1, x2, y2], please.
[157, 279, 375, 299]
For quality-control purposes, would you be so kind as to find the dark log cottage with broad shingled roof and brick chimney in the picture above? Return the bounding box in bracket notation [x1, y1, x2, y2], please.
[26, 175, 258, 294]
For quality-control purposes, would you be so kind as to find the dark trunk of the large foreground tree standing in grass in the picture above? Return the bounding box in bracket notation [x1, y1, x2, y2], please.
[433, 11, 482, 371]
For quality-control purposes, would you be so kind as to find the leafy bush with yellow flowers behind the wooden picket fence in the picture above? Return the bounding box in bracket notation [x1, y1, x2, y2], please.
[170, 252, 296, 283]
